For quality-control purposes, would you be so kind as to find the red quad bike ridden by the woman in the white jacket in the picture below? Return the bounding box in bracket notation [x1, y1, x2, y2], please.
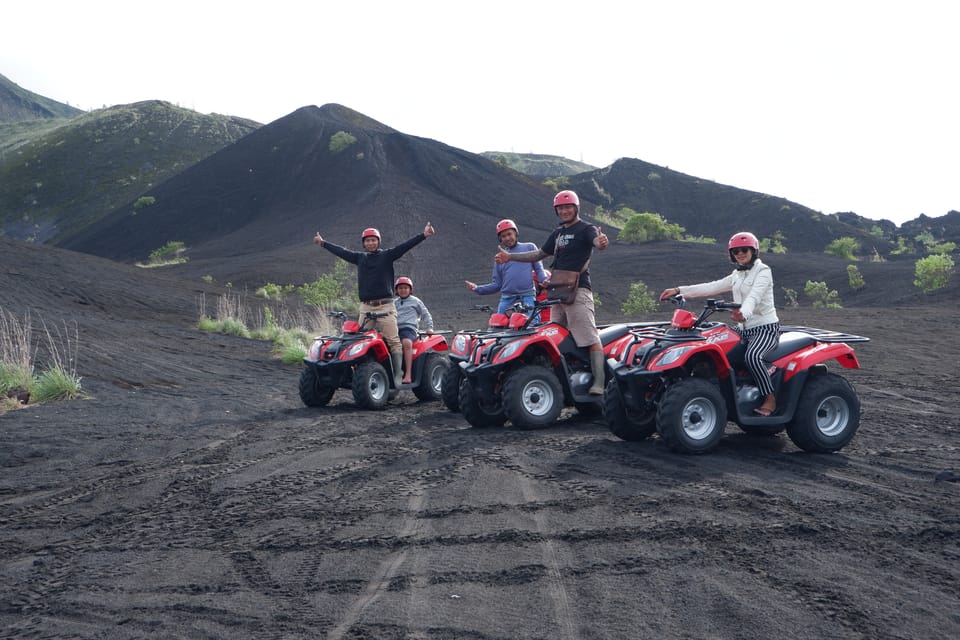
[603, 295, 869, 454]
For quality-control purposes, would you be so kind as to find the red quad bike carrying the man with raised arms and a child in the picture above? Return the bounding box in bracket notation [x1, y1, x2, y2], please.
[300, 311, 450, 409]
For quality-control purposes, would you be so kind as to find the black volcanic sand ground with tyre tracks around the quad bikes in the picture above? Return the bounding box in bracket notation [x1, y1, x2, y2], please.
[0, 239, 960, 640]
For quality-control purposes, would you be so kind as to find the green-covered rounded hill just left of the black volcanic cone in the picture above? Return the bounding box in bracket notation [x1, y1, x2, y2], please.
[0, 101, 259, 242]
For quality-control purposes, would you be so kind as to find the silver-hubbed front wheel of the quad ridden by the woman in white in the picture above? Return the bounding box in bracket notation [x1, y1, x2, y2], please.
[657, 378, 727, 453]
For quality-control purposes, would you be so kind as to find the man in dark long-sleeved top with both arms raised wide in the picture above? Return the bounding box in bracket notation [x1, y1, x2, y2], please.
[313, 222, 434, 387]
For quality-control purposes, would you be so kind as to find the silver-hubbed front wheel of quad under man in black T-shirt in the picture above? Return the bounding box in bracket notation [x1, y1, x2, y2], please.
[503, 365, 563, 429]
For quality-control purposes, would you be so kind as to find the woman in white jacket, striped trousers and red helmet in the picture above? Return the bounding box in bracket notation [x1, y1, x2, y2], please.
[660, 231, 780, 416]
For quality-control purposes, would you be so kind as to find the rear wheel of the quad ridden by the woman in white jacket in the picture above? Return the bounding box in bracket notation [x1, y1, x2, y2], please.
[787, 373, 860, 453]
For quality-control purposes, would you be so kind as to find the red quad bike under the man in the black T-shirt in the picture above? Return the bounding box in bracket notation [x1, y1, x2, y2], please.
[451, 300, 665, 429]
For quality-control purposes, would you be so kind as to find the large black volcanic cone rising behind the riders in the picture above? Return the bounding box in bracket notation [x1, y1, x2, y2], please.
[54, 105, 554, 288]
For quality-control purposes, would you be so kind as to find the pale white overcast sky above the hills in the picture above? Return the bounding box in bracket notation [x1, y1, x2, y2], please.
[0, 0, 960, 223]
